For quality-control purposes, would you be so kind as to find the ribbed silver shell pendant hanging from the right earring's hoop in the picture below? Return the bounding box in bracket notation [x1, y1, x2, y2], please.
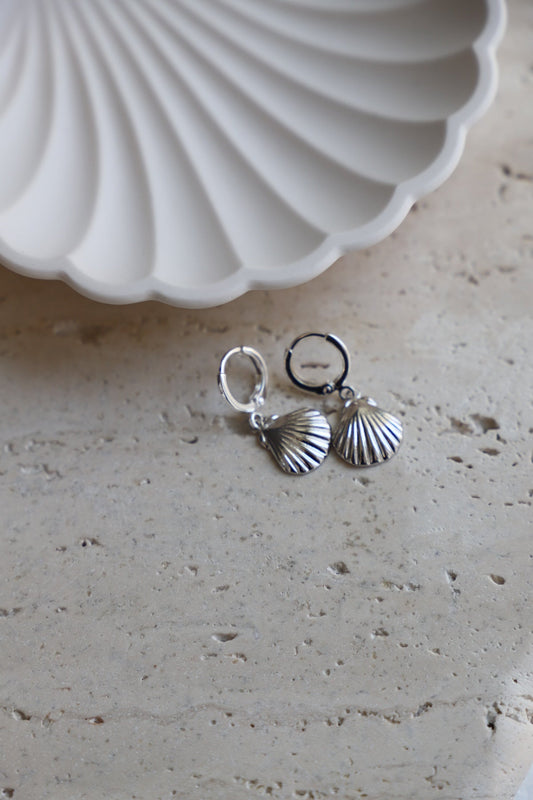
[332, 397, 402, 467]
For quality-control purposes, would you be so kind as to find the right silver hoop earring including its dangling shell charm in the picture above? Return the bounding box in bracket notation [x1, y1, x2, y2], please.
[285, 333, 403, 467]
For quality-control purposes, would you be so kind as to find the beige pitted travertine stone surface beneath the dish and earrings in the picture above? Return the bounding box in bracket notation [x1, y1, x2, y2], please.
[0, 0, 533, 800]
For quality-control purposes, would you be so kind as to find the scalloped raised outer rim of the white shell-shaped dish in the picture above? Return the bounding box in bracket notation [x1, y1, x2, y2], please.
[0, 0, 507, 308]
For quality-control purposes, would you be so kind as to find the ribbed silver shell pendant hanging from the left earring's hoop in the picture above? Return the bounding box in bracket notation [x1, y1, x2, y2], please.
[258, 408, 331, 475]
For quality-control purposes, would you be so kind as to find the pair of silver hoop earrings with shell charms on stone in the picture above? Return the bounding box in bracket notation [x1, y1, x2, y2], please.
[218, 333, 402, 475]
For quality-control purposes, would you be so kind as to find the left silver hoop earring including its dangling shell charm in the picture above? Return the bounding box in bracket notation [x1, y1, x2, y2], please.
[218, 345, 331, 475]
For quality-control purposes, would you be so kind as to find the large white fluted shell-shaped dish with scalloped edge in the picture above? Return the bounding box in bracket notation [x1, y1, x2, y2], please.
[0, 0, 505, 306]
